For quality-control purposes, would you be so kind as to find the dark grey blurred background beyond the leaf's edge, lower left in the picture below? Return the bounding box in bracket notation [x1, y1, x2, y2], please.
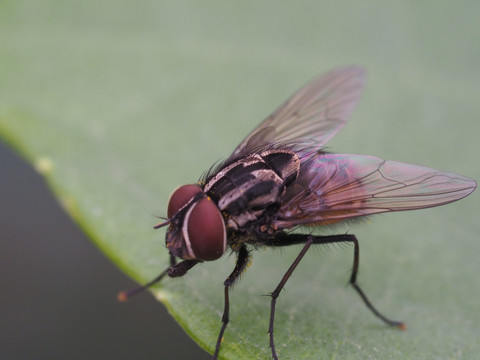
[0, 143, 210, 360]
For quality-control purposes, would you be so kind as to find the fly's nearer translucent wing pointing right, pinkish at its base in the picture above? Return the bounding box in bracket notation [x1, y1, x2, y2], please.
[275, 154, 477, 228]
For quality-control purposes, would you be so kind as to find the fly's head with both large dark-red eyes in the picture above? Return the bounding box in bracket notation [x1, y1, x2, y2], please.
[156, 185, 227, 261]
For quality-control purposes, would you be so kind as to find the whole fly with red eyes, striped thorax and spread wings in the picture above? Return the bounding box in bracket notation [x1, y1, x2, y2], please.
[119, 66, 476, 359]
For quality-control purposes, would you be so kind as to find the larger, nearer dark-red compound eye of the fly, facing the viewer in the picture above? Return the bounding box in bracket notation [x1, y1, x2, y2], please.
[186, 197, 227, 261]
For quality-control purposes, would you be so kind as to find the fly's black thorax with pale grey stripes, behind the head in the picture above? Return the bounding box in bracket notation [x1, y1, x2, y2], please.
[204, 149, 300, 231]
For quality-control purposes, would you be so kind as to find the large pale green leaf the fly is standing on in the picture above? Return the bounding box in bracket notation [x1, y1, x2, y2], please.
[0, 1, 480, 360]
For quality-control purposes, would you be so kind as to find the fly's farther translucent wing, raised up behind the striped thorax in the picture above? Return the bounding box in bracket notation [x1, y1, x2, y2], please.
[232, 66, 365, 157]
